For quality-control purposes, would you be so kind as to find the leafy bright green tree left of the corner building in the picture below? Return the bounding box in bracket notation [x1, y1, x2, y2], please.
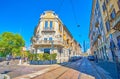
[0, 32, 25, 56]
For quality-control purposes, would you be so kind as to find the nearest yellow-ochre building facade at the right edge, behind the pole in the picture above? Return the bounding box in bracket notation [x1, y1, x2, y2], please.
[99, 0, 120, 61]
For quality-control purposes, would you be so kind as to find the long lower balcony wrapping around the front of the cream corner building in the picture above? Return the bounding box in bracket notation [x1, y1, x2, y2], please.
[34, 40, 64, 47]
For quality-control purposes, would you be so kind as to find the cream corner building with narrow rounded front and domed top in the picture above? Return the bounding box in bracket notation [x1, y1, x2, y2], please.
[31, 11, 81, 62]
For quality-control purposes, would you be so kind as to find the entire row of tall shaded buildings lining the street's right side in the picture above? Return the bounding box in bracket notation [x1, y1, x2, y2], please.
[89, 0, 120, 62]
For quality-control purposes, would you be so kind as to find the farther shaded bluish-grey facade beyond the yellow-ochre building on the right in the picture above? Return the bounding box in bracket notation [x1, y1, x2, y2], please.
[89, 0, 108, 60]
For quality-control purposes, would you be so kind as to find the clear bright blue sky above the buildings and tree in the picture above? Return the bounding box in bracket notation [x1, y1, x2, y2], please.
[0, 0, 92, 50]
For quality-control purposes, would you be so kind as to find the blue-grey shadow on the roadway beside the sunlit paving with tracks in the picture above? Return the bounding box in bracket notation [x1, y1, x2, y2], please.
[60, 58, 112, 79]
